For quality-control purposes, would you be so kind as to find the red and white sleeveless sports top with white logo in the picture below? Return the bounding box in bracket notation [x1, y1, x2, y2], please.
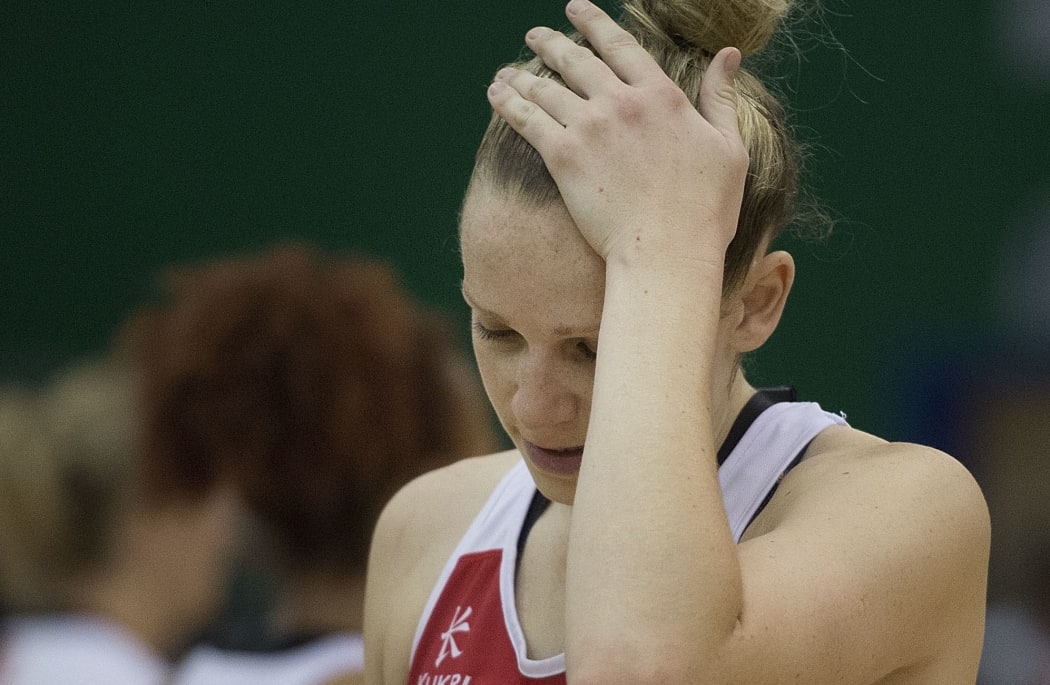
[412, 401, 846, 685]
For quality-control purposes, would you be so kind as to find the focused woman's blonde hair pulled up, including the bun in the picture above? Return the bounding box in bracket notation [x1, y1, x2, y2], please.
[468, 0, 801, 290]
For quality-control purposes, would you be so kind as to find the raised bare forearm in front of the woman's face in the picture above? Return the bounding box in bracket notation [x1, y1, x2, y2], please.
[566, 247, 741, 674]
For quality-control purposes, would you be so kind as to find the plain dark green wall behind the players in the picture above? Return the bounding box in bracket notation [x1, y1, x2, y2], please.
[0, 0, 1037, 436]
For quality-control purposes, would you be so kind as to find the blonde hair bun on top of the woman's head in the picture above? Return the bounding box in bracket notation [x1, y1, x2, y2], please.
[624, 0, 791, 56]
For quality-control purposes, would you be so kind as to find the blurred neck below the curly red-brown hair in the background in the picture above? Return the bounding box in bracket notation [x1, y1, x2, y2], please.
[277, 570, 364, 635]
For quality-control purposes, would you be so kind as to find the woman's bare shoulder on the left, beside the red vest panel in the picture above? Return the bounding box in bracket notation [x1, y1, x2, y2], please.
[364, 451, 520, 684]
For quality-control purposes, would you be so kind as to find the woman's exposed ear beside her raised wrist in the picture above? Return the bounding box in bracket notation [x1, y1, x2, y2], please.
[733, 250, 795, 354]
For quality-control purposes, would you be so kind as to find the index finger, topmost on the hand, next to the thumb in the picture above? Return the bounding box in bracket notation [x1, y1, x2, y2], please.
[565, 0, 664, 85]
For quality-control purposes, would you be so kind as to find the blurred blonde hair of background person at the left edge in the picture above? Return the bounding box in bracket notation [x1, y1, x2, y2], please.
[0, 361, 137, 610]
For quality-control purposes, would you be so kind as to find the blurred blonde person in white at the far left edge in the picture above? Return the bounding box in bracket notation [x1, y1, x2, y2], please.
[0, 360, 236, 685]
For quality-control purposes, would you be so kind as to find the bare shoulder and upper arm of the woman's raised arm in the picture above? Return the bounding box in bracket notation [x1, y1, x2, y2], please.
[726, 444, 989, 683]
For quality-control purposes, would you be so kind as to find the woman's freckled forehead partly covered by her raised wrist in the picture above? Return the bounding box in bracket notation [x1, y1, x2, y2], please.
[460, 186, 605, 325]
